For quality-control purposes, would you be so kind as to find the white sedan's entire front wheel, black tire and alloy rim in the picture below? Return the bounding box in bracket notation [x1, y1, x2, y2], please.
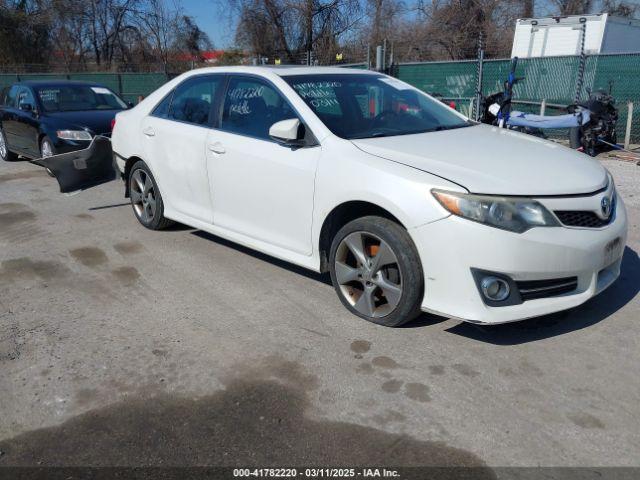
[329, 216, 424, 327]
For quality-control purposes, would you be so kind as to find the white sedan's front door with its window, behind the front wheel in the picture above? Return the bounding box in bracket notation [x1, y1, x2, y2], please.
[207, 76, 320, 255]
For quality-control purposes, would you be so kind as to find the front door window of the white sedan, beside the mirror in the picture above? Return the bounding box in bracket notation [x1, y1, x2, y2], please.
[220, 77, 297, 140]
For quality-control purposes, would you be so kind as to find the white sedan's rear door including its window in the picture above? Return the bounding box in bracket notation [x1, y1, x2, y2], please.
[142, 75, 224, 223]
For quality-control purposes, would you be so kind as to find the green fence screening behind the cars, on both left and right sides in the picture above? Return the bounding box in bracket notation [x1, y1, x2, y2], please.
[0, 53, 640, 143]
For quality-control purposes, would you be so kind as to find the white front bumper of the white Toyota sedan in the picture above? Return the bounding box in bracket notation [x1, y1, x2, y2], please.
[411, 198, 627, 324]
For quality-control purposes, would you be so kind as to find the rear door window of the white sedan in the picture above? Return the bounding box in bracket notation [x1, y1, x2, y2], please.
[169, 76, 222, 125]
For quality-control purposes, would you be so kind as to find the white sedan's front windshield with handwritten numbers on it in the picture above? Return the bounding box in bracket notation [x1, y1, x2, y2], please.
[284, 74, 473, 140]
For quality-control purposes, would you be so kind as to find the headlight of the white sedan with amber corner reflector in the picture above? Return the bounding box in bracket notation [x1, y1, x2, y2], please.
[431, 190, 560, 233]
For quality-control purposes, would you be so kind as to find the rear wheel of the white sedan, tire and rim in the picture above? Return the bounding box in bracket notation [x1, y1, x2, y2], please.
[128, 161, 174, 230]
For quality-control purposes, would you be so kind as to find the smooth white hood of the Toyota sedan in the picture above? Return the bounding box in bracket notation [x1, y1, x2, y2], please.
[353, 125, 607, 196]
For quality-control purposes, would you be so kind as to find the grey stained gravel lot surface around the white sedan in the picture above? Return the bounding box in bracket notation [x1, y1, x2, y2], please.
[0, 155, 640, 466]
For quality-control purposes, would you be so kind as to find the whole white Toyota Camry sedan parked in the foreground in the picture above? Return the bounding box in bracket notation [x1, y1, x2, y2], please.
[52, 67, 627, 326]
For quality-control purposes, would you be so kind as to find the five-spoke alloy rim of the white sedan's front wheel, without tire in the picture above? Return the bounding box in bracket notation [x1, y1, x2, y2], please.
[334, 232, 403, 318]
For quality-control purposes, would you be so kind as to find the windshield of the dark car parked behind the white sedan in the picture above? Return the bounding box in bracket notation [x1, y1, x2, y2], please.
[37, 85, 127, 112]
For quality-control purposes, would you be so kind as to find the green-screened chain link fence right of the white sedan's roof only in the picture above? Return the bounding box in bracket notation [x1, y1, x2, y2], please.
[395, 53, 640, 143]
